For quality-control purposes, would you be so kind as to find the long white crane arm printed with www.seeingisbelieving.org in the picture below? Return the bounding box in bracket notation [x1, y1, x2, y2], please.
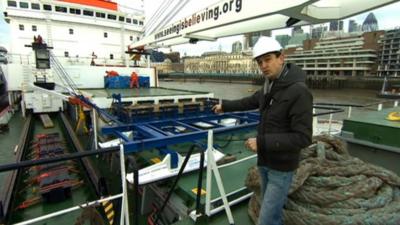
[130, 0, 399, 49]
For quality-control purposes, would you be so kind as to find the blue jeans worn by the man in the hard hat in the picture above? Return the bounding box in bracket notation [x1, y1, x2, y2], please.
[258, 166, 294, 225]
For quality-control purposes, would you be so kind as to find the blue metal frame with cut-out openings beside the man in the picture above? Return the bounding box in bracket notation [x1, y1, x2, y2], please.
[102, 111, 259, 153]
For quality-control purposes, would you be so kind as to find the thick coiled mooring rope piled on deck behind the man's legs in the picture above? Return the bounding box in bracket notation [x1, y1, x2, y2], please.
[246, 137, 400, 225]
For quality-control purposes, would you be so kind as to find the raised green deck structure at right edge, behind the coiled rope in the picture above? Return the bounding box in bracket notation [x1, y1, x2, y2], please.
[338, 107, 400, 174]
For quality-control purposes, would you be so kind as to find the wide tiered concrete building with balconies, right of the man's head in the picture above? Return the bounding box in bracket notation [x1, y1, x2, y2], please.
[286, 31, 383, 76]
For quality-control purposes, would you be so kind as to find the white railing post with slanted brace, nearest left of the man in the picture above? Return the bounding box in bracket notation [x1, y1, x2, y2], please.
[206, 130, 234, 224]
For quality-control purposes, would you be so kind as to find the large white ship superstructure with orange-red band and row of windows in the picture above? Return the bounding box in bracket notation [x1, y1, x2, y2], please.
[1, 0, 214, 116]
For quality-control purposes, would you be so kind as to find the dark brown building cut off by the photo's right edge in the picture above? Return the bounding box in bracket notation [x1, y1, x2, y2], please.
[378, 28, 400, 76]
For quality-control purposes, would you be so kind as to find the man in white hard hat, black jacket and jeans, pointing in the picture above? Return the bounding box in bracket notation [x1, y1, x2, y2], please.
[213, 37, 313, 225]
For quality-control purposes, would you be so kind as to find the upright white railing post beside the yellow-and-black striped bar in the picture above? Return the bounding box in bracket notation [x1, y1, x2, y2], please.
[119, 144, 130, 225]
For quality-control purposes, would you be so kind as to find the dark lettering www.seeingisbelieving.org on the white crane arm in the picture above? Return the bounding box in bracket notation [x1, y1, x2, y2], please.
[154, 0, 242, 39]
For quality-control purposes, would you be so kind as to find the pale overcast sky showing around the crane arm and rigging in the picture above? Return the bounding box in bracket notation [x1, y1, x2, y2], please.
[0, 0, 400, 55]
